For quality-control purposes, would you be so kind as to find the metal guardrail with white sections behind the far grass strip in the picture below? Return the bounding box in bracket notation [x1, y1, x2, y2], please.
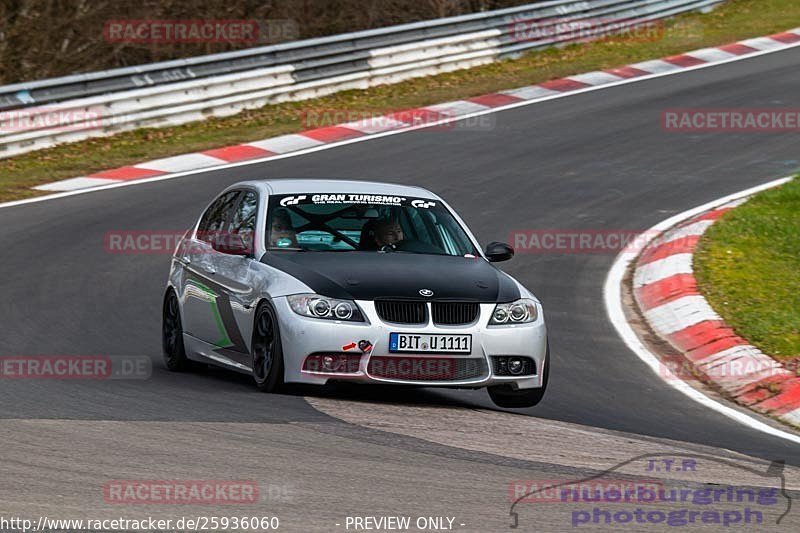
[0, 0, 724, 157]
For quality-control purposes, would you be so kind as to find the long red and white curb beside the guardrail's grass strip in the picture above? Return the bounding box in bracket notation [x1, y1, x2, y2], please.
[34, 28, 800, 192]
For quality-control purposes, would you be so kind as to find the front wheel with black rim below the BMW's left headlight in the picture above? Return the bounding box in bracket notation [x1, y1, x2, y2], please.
[250, 302, 283, 392]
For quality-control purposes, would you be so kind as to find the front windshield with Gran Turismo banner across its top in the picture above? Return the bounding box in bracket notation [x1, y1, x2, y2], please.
[265, 193, 477, 256]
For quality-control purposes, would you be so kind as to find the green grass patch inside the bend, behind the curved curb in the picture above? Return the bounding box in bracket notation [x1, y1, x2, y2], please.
[694, 178, 800, 361]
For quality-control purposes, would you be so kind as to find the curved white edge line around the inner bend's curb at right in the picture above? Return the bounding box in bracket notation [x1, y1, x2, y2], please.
[603, 176, 800, 444]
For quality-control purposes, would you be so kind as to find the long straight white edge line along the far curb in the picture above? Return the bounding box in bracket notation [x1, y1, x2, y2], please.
[0, 41, 800, 209]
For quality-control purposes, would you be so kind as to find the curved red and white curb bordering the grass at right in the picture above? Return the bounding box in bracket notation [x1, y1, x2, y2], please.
[633, 193, 800, 426]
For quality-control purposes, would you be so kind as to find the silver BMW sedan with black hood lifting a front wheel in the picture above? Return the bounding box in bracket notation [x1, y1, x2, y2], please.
[162, 180, 550, 407]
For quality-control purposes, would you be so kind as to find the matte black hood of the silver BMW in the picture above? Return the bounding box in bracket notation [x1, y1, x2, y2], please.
[261, 251, 520, 303]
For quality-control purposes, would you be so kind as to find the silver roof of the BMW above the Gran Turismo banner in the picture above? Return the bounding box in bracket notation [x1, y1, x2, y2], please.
[231, 179, 440, 199]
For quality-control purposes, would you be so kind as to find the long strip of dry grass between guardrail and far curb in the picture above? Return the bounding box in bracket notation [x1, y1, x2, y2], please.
[0, 0, 800, 201]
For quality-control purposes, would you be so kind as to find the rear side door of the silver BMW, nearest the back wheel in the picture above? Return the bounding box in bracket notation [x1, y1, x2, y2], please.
[178, 190, 242, 348]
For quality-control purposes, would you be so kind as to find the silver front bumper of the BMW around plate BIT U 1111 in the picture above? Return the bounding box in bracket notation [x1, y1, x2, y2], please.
[272, 297, 547, 389]
